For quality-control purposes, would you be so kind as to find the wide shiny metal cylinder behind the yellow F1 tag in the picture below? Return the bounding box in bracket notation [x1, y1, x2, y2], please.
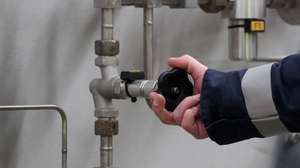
[229, 0, 266, 61]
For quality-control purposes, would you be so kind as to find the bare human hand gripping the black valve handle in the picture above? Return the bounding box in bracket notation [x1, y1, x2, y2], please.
[150, 55, 208, 139]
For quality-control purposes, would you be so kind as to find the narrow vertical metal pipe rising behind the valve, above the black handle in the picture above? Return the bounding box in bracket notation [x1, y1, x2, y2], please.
[144, 7, 154, 79]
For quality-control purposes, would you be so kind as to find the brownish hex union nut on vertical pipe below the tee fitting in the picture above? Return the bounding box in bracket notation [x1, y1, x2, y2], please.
[95, 119, 119, 136]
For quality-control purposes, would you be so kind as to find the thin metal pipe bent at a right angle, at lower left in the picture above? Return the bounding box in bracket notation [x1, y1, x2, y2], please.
[0, 105, 68, 168]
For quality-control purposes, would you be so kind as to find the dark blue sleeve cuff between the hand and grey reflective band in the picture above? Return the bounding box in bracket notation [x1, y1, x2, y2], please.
[201, 69, 263, 145]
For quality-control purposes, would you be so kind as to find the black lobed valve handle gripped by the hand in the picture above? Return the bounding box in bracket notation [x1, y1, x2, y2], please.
[157, 69, 194, 112]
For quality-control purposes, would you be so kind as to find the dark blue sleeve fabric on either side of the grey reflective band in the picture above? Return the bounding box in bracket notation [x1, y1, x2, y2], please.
[201, 54, 300, 145]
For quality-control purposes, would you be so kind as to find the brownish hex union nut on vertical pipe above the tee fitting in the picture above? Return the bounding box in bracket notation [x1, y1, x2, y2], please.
[95, 40, 120, 56]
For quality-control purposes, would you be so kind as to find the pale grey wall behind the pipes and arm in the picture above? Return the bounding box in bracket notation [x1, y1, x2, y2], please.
[0, 0, 300, 168]
